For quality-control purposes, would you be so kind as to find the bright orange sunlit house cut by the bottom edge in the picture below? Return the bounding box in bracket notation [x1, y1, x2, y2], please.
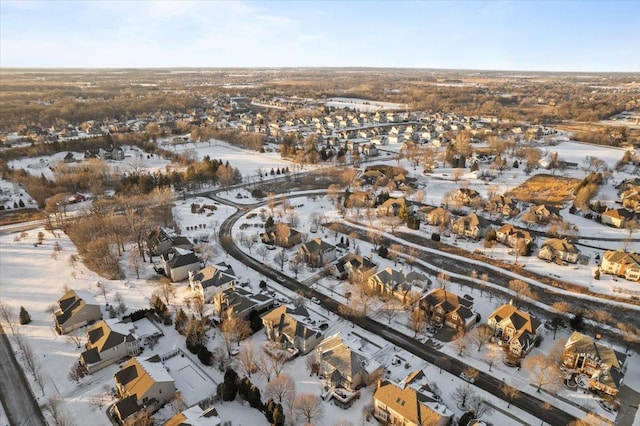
[373, 371, 453, 426]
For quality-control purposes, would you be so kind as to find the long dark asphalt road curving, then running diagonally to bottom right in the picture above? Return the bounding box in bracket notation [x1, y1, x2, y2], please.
[220, 200, 576, 426]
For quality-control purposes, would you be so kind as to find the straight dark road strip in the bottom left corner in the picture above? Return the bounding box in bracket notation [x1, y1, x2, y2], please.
[0, 324, 47, 426]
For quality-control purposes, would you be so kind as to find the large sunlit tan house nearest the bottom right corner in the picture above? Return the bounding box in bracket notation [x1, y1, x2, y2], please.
[562, 331, 626, 397]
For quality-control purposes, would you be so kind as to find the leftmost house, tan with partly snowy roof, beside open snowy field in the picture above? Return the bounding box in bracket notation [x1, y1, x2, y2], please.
[54, 290, 102, 334]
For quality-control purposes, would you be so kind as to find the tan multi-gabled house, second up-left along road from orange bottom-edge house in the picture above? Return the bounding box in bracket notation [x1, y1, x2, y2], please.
[262, 305, 324, 354]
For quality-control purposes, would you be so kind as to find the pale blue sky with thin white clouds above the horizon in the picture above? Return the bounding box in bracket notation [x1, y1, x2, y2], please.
[0, 0, 640, 72]
